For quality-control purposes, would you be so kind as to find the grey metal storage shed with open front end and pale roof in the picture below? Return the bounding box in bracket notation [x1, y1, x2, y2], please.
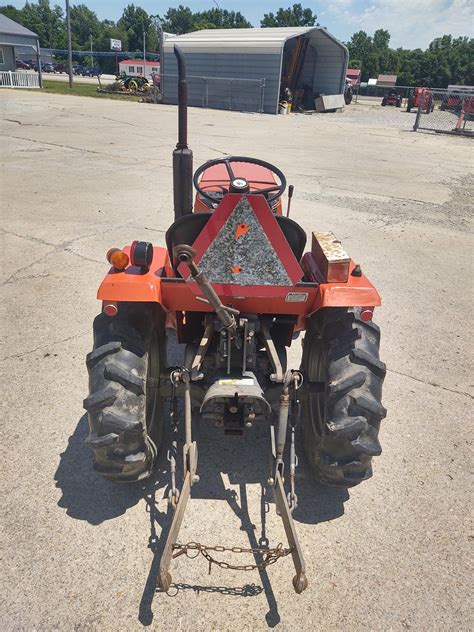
[161, 26, 348, 114]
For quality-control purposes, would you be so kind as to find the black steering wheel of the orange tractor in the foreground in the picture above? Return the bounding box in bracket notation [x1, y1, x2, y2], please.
[193, 156, 286, 204]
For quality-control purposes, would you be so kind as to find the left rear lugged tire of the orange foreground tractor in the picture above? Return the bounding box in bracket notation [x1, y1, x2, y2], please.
[84, 303, 166, 483]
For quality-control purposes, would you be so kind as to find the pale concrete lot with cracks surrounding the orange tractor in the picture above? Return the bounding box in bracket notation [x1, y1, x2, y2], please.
[0, 90, 474, 632]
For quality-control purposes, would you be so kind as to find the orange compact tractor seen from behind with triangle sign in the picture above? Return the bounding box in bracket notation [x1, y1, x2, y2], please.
[84, 46, 386, 593]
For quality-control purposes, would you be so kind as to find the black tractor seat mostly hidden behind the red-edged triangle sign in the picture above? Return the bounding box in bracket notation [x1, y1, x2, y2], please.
[166, 213, 306, 265]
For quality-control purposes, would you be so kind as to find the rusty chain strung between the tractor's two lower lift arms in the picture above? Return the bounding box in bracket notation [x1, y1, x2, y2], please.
[173, 542, 293, 574]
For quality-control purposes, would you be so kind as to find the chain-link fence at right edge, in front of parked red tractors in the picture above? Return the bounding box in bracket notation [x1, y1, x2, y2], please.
[408, 88, 474, 136]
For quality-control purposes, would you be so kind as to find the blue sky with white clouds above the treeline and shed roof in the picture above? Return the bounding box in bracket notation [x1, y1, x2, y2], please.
[5, 0, 474, 48]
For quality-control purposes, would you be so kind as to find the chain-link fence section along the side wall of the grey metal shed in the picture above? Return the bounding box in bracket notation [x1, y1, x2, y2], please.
[161, 74, 265, 112]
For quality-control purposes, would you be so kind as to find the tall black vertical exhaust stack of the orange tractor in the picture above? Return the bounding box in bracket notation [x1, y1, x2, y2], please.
[173, 45, 193, 220]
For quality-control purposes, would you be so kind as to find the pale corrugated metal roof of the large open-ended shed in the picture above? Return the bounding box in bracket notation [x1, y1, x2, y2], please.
[163, 26, 344, 54]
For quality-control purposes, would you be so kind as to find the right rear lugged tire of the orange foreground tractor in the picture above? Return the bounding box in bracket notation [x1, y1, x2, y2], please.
[301, 307, 386, 487]
